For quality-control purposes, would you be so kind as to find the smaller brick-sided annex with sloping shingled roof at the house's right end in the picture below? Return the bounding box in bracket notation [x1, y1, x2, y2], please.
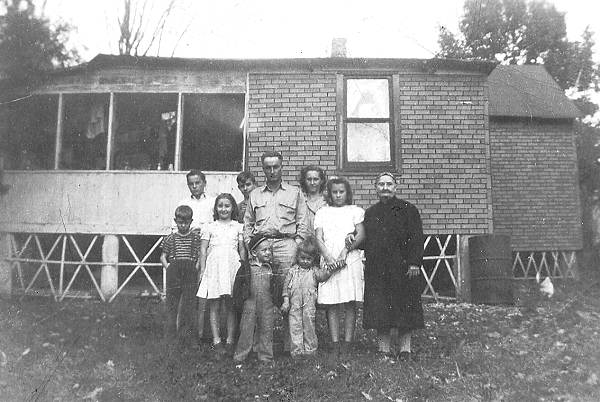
[488, 65, 583, 276]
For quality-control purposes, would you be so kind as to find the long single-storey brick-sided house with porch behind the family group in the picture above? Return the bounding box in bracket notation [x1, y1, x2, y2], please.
[0, 55, 581, 300]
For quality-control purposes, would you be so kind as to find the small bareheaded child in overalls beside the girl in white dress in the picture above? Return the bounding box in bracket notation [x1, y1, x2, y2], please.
[281, 238, 331, 358]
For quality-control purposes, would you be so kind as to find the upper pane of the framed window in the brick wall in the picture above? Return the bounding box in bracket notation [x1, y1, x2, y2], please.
[346, 79, 390, 118]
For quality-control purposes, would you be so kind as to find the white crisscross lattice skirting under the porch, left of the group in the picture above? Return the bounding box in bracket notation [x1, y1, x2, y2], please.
[6, 234, 166, 302]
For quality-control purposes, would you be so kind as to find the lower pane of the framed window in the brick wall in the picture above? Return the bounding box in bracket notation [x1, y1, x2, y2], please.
[346, 123, 391, 162]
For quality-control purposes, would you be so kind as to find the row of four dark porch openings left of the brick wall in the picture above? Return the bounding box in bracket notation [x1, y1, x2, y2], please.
[0, 92, 245, 171]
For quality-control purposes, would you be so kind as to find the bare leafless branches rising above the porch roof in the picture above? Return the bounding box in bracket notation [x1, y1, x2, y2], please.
[117, 0, 191, 57]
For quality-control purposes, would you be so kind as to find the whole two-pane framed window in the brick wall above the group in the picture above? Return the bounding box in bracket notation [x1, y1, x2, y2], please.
[342, 77, 394, 170]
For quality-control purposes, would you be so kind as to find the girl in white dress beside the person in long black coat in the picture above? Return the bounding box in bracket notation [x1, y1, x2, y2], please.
[314, 177, 365, 357]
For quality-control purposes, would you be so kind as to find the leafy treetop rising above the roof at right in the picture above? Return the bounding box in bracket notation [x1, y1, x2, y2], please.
[438, 0, 598, 89]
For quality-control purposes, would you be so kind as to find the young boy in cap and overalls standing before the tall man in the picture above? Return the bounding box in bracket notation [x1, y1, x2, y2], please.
[233, 236, 275, 362]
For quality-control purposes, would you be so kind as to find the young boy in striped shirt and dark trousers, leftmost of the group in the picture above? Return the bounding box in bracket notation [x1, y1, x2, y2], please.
[160, 205, 200, 342]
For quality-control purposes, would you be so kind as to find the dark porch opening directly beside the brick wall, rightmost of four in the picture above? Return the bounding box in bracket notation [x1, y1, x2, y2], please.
[181, 94, 245, 171]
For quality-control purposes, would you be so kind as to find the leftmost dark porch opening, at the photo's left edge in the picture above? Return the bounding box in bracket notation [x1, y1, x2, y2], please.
[0, 95, 58, 170]
